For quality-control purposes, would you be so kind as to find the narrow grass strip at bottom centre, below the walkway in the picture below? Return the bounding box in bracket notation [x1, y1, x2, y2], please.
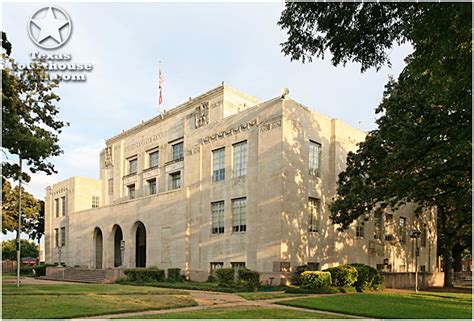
[126, 306, 340, 319]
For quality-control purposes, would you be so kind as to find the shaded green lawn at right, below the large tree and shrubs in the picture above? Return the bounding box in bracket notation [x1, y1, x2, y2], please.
[278, 292, 472, 319]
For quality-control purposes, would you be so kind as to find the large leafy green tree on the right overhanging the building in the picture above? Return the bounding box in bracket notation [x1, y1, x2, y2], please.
[279, 3, 472, 286]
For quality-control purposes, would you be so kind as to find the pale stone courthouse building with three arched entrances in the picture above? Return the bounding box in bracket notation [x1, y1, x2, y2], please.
[45, 83, 436, 280]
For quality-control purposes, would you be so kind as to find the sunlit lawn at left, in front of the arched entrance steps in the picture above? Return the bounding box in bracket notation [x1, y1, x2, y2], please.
[2, 284, 197, 319]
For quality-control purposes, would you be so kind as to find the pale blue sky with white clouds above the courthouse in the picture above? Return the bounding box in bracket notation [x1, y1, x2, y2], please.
[2, 2, 412, 238]
